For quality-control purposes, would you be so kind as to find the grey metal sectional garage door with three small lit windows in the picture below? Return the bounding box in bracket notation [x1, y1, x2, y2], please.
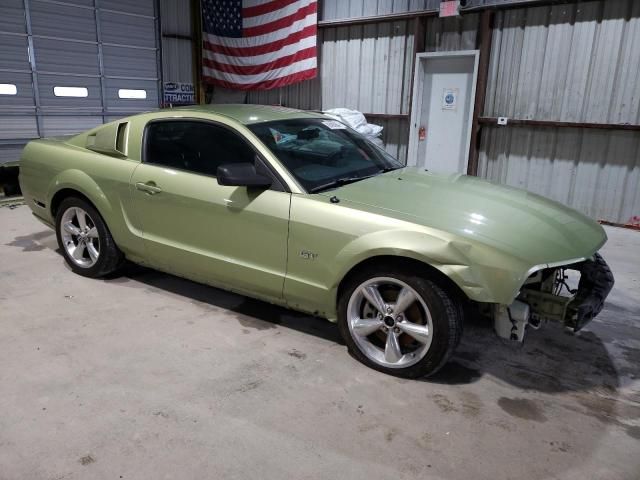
[0, 0, 160, 164]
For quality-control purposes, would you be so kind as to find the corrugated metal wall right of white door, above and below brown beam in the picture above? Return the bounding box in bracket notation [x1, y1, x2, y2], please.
[479, 0, 640, 222]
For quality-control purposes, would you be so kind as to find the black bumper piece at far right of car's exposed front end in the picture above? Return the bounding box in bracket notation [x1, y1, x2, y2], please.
[565, 253, 614, 332]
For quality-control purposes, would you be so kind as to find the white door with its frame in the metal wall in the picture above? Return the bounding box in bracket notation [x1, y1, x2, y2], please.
[407, 50, 478, 173]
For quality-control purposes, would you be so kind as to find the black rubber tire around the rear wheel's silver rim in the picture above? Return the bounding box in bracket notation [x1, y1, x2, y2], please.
[56, 197, 124, 278]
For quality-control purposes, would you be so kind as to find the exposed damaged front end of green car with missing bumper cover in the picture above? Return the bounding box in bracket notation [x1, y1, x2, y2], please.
[493, 253, 614, 342]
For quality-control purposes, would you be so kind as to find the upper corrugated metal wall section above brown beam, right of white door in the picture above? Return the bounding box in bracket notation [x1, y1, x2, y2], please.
[484, 0, 640, 123]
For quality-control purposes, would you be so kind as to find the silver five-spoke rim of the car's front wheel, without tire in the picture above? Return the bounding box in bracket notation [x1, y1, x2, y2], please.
[347, 277, 433, 368]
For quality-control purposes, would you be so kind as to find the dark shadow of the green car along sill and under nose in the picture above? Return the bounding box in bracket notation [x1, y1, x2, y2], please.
[115, 265, 619, 393]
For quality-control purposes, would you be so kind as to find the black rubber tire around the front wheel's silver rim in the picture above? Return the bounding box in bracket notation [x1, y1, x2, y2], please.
[338, 264, 463, 378]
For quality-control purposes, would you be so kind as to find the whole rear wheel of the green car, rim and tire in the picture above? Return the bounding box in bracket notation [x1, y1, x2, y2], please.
[56, 197, 123, 278]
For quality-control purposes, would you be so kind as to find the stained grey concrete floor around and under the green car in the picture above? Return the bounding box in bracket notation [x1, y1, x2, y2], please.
[0, 206, 640, 480]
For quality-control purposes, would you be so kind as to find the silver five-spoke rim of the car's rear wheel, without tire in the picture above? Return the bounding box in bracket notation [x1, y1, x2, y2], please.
[60, 207, 100, 268]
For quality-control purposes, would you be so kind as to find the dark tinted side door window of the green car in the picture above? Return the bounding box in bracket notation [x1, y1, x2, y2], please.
[144, 120, 255, 177]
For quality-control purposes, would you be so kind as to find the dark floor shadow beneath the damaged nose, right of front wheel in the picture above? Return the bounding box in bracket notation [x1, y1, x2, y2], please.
[426, 317, 620, 393]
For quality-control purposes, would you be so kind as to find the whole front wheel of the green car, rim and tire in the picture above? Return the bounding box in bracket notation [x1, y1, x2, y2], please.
[338, 268, 462, 378]
